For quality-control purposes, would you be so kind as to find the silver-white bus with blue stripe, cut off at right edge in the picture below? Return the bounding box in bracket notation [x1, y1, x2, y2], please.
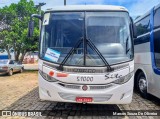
[134, 4, 160, 98]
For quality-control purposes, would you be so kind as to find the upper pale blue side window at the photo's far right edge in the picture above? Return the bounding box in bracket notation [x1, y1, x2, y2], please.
[154, 8, 160, 28]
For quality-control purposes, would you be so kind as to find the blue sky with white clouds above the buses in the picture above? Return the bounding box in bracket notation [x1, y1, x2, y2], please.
[0, 0, 160, 17]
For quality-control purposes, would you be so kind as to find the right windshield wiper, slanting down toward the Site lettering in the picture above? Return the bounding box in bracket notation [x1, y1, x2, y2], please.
[86, 39, 114, 72]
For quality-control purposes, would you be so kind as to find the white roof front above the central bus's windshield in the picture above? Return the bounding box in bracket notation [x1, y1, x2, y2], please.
[46, 5, 128, 12]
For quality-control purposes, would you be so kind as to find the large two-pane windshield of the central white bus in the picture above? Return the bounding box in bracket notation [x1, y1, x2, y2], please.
[40, 12, 133, 66]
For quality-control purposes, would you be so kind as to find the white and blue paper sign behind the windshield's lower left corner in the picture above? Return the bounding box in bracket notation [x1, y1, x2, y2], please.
[44, 48, 61, 62]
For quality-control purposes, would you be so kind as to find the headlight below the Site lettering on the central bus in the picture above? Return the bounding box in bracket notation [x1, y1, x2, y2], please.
[112, 71, 134, 84]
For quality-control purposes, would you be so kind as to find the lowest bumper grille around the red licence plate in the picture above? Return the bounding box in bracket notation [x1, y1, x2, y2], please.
[59, 92, 112, 102]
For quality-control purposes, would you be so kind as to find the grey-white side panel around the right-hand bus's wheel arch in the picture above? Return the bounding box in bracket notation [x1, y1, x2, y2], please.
[134, 42, 155, 94]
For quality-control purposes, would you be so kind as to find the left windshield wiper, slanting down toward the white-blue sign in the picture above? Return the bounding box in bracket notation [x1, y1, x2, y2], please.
[58, 38, 83, 71]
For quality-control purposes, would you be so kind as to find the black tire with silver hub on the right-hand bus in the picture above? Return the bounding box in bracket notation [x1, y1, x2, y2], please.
[137, 72, 149, 99]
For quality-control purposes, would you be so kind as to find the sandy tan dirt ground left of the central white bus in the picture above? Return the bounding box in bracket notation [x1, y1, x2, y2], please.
[0, 71, 38, 110]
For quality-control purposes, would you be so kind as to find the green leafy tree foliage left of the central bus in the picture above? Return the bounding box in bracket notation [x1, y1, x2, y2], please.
[0, 0, 39, 60]
